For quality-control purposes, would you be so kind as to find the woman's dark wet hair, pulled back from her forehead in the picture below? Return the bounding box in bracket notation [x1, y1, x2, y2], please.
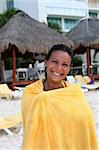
[45, 44, 73, 78]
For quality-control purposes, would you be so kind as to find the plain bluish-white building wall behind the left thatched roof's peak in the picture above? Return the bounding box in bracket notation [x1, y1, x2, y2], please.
[14, 0, 46, 22]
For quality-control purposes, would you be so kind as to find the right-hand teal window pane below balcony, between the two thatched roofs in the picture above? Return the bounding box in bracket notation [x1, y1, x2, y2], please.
[64, 19, 78, 30]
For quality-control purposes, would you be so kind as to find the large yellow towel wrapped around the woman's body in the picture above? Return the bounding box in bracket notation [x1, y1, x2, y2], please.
[22, 81, 97, 150]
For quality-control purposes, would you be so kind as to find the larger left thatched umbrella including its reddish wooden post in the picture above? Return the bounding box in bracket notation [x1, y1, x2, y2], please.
[0, 12, 73, 86]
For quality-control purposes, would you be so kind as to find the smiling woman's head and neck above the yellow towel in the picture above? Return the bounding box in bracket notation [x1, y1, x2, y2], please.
[44, 44, 72, 90]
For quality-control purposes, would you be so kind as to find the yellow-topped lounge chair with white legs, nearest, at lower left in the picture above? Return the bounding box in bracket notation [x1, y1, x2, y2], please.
[0, 112, 22, 135]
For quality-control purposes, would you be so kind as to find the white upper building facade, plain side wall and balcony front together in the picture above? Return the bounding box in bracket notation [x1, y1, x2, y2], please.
[14, 0, 87, 22]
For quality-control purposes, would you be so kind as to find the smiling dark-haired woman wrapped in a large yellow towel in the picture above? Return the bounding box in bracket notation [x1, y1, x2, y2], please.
[22, 44, 97, 150]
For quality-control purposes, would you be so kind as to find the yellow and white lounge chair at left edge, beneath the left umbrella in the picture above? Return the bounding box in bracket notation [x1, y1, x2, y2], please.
[0, 83, 23, 99]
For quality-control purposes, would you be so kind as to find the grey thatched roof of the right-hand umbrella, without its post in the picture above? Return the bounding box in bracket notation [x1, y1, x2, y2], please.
[66, 18, 99, 52]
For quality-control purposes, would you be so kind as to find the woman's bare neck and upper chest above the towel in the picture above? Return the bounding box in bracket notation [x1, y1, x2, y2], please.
[44, 80, 63, 91]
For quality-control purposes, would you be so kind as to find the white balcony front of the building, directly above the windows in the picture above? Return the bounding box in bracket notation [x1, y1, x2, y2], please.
[46, 0, 87, 16]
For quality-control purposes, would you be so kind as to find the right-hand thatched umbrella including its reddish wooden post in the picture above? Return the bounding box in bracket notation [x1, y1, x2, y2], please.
[66, 18, 99, 79]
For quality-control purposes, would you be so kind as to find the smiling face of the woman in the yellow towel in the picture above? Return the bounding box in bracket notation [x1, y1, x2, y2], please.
[45, 50, 71, 82]
